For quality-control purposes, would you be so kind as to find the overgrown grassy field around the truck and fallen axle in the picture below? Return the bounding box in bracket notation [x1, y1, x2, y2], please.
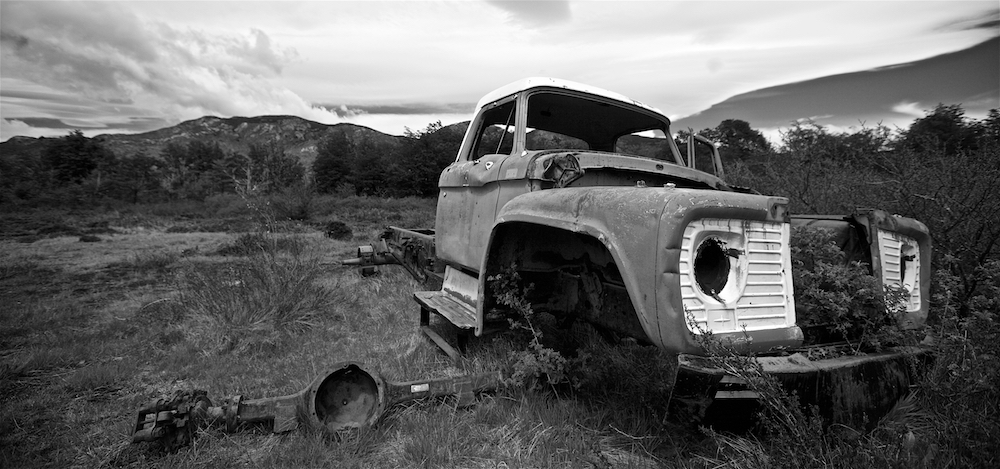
[0, 198, 1000, 468]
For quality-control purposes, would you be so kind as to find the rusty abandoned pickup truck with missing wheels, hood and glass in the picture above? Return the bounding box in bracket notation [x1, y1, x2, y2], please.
[345, 78, 931, 424]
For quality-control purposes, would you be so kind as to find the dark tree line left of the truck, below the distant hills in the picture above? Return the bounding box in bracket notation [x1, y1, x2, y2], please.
[0, 122, 464, 206]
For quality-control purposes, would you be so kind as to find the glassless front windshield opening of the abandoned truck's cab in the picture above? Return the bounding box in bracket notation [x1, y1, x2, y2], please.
[525, 92, 673, 161]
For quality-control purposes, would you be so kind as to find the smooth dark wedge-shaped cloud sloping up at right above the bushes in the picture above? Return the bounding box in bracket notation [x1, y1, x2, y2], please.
[673, 37, 1000, 130]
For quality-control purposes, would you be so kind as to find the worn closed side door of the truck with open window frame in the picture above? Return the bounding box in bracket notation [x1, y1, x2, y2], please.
[435, 96, 516, 271]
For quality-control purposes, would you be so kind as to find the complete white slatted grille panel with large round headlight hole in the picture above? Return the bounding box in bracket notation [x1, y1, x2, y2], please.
[679, 219, 795, 333]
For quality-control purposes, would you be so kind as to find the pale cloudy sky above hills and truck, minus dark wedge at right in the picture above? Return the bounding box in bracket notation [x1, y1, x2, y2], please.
[0, 0, 1000, 140]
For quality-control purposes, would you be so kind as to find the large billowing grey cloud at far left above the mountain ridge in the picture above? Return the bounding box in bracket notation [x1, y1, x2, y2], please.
[0, 2, 341, 136]
